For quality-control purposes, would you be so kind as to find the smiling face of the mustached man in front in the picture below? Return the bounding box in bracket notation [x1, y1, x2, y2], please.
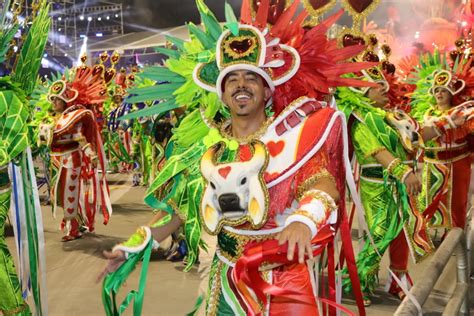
[222, 70, 272, 116]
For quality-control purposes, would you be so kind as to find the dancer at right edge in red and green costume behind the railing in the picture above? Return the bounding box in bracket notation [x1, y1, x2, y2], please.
[412, 53, 474, 229]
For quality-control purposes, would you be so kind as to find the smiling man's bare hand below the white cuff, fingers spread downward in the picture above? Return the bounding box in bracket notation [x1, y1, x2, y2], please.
[277, 222, 313, 263]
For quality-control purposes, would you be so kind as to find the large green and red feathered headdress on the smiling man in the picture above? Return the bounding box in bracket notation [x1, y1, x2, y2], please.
[123, 0, 373, 122]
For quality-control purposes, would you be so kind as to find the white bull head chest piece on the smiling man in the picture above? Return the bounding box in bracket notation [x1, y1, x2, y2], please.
[201, 141, 268, 234]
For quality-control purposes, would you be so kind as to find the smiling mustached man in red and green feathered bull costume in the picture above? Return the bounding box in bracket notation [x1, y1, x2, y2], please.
[96, 0, 382, 315]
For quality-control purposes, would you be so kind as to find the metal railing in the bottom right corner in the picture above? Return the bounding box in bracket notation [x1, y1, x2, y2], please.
[394, 228, 469, 316]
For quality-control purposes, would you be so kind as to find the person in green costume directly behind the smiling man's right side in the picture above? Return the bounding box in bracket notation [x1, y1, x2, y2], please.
[336, 65, 431, 306]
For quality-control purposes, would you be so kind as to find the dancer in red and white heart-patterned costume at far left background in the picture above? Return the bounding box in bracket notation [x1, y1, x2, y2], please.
[48, 65, 112, 241]
